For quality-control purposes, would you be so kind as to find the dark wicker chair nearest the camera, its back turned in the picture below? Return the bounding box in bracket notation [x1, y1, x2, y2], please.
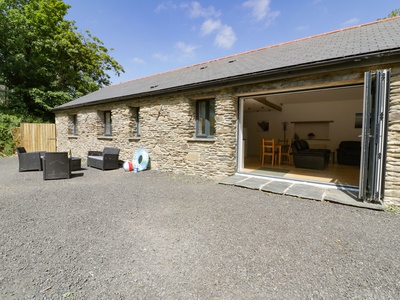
[43, 152, 71, 180]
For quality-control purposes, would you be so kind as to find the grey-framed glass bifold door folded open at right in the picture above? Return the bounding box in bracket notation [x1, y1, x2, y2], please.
[358, 70, 390, 202]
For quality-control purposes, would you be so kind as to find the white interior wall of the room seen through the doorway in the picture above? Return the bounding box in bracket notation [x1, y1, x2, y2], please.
[243, 99, 363, 156]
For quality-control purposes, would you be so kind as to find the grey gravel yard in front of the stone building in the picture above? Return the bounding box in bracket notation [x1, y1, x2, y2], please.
[0, 157, 400, 299]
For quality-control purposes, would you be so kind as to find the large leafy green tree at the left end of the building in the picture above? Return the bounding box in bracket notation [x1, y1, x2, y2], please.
[0, 0, 124, 121]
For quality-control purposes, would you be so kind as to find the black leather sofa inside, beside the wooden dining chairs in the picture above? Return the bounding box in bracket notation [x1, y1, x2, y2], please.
[292, 140, 331, 170]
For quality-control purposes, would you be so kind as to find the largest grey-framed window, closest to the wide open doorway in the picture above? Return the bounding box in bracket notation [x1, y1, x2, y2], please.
[196, 99, 215, 138]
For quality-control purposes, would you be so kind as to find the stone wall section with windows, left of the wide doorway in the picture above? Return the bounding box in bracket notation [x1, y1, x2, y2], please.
[56, 90, 237, 179]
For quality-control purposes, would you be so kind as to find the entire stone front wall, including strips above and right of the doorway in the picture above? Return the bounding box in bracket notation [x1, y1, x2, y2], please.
[56, 66, 400, 205]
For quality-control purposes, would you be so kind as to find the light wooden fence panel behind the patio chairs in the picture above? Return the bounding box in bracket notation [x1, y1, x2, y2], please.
[19, 123, 57, 152]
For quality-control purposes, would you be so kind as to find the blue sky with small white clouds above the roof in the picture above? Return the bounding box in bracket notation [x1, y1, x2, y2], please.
[64, 0, 400, 84]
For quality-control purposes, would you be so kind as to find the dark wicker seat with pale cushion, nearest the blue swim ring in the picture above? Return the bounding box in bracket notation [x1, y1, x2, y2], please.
[87, 147, 119, 171]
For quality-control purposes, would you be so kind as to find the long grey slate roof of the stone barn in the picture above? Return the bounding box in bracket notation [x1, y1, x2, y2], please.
[54, 17, 400, 110]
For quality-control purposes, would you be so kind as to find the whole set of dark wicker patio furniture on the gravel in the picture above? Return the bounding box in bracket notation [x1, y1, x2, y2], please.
[17, 147, 119, 180]
